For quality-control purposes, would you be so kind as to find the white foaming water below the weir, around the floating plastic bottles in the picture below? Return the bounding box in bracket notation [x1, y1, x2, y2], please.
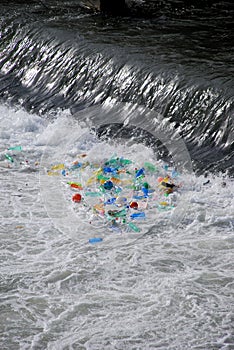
[0, 106, 234, 350]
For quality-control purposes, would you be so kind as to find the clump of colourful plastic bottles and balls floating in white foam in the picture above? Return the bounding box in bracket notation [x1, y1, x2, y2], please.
[47, 154, 181, 233]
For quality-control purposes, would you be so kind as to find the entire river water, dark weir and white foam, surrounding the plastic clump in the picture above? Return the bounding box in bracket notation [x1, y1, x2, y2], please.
[0, 1, 234, 350]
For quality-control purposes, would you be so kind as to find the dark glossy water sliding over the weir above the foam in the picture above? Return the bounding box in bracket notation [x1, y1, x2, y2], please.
[0, 1, 234, 175]
